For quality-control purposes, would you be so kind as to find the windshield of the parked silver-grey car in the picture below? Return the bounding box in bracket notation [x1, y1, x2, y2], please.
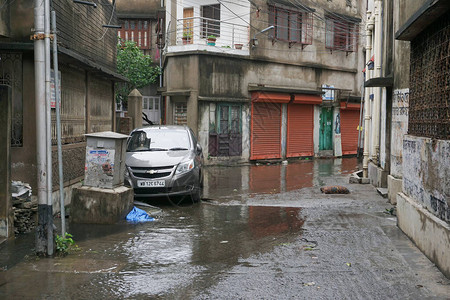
[127, 129, 190, 152]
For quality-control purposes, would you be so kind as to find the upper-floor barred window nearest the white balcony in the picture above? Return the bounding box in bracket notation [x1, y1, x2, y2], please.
[269, 5, 313, 45]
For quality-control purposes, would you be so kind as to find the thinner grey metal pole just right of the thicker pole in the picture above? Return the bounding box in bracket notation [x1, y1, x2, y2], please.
[52, 10, 66, 237]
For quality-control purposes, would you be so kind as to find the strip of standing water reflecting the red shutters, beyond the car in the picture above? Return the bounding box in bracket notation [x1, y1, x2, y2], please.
[204, 158, 358, 200]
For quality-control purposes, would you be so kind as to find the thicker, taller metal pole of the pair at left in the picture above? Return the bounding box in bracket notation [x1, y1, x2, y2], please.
[44, 0, 53, 256]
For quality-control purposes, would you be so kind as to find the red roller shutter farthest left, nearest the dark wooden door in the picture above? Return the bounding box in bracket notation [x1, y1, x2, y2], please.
[250, 103, 281, 159]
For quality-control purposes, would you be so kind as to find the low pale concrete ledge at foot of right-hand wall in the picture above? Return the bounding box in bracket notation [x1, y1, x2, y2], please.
[397, 193, 450, 278]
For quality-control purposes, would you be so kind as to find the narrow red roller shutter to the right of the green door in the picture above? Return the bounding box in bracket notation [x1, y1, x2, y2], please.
[341, 109, 359, 155]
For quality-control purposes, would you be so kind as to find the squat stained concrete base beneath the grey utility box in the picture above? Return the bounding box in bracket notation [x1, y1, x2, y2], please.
[70, 186, 134, 224]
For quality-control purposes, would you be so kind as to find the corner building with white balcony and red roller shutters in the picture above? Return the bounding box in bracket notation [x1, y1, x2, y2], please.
[162, 0, 365, 163]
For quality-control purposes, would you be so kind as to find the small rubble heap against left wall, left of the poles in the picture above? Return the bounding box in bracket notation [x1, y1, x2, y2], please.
[11, 181, 38, 234]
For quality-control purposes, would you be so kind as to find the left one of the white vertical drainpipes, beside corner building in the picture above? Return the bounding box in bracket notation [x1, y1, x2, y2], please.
[363, 12, 374, 178]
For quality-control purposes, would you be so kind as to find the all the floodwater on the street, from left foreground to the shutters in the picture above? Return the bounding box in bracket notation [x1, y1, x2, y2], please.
[0, 159, 357, 299]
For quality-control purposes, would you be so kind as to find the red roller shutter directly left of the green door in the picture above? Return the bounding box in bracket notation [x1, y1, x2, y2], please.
[286, 104, 314, 157]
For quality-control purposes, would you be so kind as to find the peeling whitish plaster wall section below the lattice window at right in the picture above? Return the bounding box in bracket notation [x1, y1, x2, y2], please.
[403, 135, 450, 222]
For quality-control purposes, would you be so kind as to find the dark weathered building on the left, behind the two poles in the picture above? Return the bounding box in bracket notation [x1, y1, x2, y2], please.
[0, 0, 124, 235]
